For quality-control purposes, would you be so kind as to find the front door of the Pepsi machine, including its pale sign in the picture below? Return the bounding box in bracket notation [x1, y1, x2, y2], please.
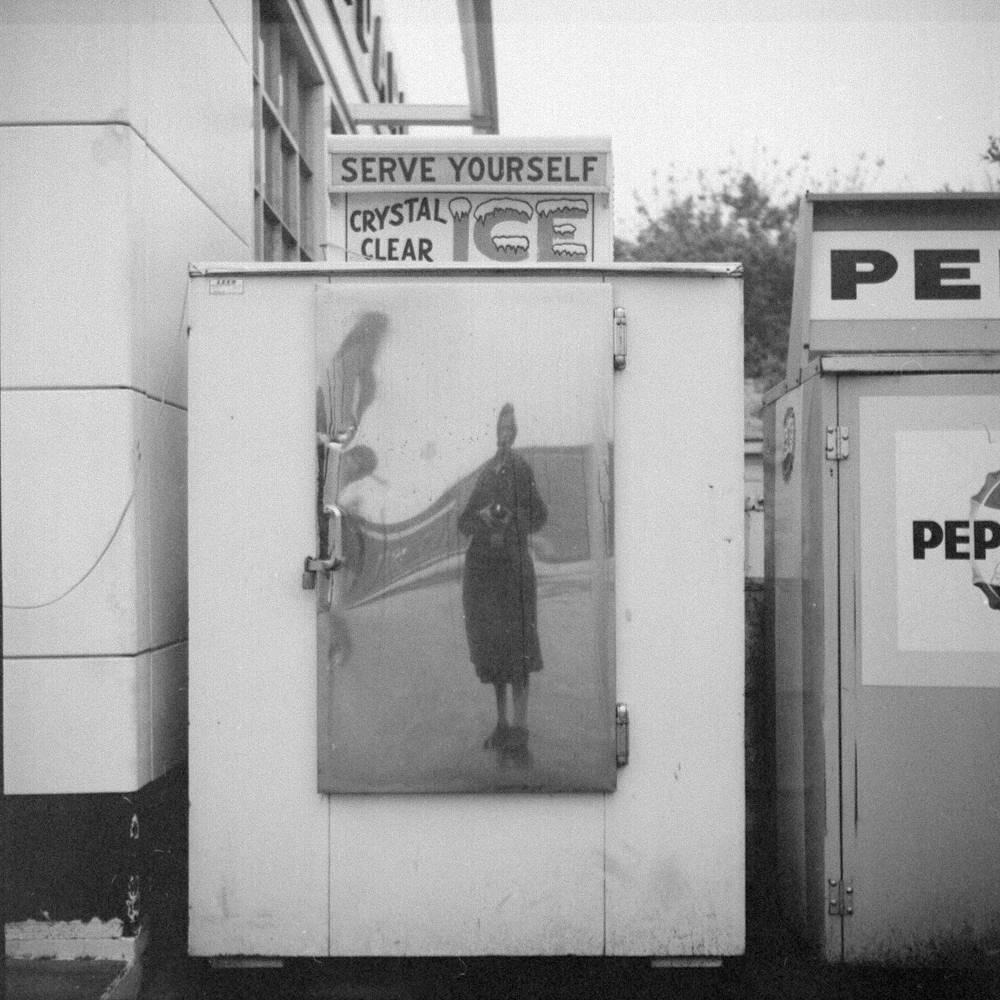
[829, 372, 1000, 961]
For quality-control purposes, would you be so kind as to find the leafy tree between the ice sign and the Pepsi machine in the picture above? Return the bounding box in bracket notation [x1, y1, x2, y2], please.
[615, 156, 882, 385]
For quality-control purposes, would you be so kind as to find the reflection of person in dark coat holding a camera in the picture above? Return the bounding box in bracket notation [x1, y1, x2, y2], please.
[458, 403, 548, 749]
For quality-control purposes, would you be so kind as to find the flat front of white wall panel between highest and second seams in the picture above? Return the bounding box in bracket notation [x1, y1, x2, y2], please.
[0, 125, 141, 387]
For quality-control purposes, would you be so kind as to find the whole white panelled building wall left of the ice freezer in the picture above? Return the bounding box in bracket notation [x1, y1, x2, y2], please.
[0, 0, 253, 795]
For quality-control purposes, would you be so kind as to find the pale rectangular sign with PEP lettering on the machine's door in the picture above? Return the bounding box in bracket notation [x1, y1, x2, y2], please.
[859, 395, 1000, 687]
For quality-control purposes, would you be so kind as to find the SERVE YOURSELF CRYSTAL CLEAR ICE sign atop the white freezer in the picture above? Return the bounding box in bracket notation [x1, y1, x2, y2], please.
[327, 136, 613, 265]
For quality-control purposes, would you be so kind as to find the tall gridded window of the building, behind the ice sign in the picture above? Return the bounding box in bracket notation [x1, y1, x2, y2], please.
[253, 0, 326, 261]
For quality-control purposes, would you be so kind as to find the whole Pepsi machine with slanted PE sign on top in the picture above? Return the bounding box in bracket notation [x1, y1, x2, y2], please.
[765, 195, 1000, 962]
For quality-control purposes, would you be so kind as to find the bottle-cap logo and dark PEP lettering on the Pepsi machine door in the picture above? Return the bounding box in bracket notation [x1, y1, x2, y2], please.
[913, 470, 1000, 611]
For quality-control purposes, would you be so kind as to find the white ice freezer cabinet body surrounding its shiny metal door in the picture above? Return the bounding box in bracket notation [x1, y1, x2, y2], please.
[189, 266, 744, 956]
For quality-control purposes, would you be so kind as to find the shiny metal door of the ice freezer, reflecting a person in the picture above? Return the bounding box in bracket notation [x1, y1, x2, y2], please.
[316, 280, 615, 792]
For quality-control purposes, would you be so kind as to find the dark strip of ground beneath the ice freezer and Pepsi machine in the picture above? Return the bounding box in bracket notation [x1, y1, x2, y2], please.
[141, 958, 1000, 1000]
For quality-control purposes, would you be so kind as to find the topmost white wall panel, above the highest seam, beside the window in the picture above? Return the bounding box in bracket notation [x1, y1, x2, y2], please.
[0, 0, 253, 242]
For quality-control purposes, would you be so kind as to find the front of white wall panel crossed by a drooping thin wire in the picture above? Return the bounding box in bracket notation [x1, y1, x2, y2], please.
[0, 389, 149, 656]
